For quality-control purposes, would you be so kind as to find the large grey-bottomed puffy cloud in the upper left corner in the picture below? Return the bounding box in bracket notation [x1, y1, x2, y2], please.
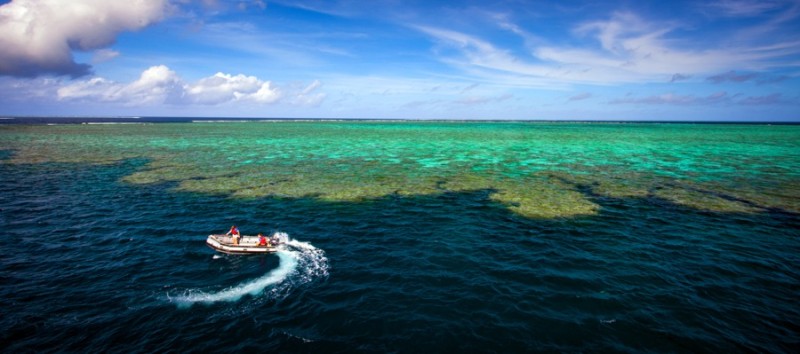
[0, 0, 168, 77]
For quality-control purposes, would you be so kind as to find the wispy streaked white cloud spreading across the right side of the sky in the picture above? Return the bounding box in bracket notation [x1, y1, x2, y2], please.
[412, 10, 800, 87]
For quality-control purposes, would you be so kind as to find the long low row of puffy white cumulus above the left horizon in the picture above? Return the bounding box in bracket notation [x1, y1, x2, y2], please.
[58, 65, 326, 106]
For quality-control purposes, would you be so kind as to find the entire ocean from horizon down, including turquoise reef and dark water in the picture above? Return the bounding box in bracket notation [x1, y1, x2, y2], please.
[0, 119, 800, 353]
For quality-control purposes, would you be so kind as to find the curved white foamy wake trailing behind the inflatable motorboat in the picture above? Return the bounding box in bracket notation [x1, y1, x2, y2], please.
[169, 234, 328, 308]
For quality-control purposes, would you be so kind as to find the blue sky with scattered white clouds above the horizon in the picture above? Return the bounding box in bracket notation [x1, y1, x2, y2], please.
[0, 0, 800, 121]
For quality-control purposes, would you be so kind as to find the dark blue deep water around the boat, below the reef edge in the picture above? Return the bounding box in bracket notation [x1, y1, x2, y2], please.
[0, 159, 800, 353]
